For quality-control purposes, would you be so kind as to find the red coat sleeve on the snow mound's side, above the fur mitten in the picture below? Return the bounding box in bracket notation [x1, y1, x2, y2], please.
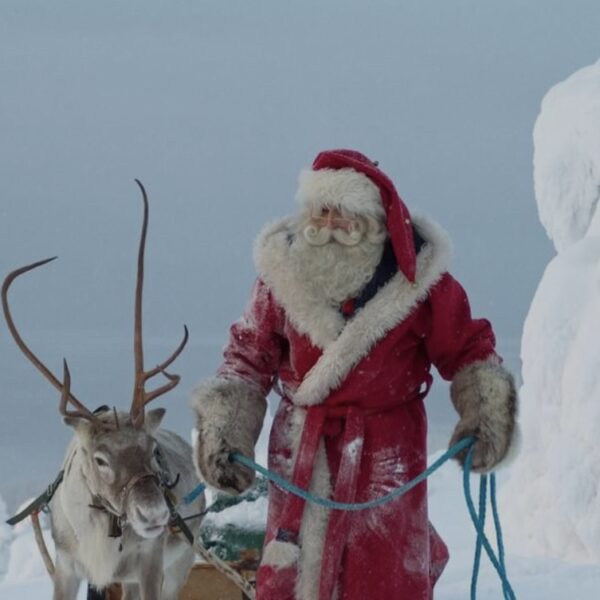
[425, 273, 496, 380]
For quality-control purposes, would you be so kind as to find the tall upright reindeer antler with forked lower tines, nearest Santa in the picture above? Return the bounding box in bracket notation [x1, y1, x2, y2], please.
[130, 179, 189, 427]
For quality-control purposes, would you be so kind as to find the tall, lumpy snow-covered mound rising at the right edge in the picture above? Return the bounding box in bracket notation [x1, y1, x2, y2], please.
[503, 57, 600, 563]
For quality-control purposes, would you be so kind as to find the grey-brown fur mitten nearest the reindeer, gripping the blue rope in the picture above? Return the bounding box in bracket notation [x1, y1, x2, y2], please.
[192, 377, 266, 494]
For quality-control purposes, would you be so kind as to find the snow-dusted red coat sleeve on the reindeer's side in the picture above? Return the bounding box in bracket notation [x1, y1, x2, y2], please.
[217, 279, 286, 396]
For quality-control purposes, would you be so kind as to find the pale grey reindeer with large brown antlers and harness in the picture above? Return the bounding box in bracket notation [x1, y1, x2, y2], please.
[2, 179, 204, 600]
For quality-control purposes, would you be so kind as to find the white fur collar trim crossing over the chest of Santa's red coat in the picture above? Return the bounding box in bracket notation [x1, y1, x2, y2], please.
[255, 216, 452, 406]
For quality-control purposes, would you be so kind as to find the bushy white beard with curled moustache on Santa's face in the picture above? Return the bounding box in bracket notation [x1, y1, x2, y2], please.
[290, 227, 384, 306]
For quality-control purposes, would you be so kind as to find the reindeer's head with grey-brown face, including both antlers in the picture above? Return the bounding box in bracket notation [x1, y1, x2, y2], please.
[2, 179, 188, 538]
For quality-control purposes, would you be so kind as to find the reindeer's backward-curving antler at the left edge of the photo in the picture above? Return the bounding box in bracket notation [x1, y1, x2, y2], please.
[2, 256, 113, 429]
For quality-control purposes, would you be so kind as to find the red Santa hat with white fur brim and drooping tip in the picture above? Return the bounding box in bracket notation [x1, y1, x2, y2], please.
[296, 150, 416, 282]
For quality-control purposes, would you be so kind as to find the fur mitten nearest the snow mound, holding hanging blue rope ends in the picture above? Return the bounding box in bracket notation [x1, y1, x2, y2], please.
[450, 357, 517, 473]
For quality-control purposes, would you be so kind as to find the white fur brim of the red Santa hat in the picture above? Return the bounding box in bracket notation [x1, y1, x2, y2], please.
[296, 168, 385, 218]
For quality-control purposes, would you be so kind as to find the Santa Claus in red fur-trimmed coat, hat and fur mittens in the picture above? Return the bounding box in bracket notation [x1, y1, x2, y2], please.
[193, 150, 516, 600]
